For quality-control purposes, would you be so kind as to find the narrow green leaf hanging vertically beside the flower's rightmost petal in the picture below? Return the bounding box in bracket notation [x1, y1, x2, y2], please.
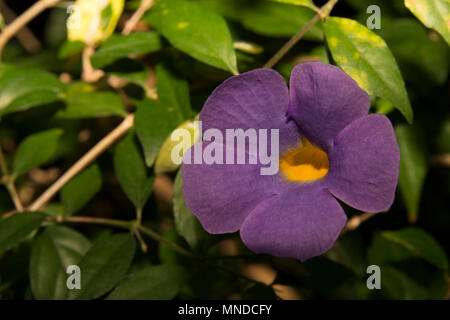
[395, 124, 428, 222]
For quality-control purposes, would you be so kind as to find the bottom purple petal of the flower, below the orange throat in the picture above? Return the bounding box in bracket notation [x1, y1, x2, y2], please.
[241, 184, 347, 261]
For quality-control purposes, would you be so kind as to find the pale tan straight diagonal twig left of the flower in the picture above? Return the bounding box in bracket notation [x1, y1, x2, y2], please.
[29, 114, 134, 211]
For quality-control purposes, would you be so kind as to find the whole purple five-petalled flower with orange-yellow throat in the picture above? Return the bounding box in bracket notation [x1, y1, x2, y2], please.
[182, 62, 400, 261]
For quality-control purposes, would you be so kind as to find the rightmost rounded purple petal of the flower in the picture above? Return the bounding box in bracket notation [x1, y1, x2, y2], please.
[327, 114, 400, 212]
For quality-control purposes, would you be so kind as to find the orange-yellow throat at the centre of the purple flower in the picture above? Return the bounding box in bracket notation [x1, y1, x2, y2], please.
[280, 138, 329, 182]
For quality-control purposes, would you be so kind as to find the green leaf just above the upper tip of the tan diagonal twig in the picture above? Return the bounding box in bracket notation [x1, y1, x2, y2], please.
[57, 82, 128, 119]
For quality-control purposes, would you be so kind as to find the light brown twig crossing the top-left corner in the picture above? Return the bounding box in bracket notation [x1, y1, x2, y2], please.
[0, 0, 61, 60]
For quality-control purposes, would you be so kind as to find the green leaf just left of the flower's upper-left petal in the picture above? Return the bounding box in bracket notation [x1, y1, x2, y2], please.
[156, 63, 192, 122]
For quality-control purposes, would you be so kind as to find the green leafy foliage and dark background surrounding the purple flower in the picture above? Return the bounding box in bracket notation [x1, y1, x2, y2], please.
[0, 0, 450, 299]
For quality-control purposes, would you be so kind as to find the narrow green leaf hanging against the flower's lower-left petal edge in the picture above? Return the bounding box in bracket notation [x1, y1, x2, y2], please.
[173, 170, 207, 249]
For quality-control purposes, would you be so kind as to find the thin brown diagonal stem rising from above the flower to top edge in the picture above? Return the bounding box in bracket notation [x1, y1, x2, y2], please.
[263, 0, 339, 68]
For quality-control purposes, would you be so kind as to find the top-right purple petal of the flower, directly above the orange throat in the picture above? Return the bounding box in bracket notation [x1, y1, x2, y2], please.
[288, 62, 370, 151]
